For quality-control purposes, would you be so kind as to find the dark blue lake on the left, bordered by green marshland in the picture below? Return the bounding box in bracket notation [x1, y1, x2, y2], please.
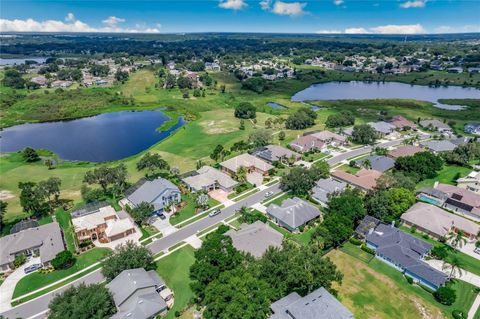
[0, 111, 185, 162]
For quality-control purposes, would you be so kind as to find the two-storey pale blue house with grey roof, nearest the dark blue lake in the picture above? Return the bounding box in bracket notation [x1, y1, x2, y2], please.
[126, 177, 182, 213]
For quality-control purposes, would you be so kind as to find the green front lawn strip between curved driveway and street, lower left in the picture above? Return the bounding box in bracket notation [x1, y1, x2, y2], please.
[13, 248, 110, 298]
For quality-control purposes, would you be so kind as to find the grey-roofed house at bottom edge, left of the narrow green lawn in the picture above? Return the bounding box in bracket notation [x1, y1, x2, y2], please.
[106, 268, 173, 319]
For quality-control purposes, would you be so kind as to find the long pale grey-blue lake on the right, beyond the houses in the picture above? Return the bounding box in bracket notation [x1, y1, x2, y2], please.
[292, 81, 480, 110]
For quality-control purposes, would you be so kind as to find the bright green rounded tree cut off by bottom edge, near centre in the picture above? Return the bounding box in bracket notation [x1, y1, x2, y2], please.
[203, 269, 273, 319]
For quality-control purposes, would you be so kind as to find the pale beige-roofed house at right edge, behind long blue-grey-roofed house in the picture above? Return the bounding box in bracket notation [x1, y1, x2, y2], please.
[401, 202, 480, 240]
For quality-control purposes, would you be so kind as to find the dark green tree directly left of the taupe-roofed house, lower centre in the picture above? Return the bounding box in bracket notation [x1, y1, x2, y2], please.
[190, 226, 243, 301]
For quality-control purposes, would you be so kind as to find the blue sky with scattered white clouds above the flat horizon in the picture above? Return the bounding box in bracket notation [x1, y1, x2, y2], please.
[0, 0, 480, 34]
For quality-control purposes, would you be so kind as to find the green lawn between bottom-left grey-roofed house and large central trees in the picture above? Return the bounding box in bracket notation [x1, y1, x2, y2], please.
[157, 245, 195, 319]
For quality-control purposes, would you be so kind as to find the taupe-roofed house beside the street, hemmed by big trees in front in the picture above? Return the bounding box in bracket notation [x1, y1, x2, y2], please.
[225, 220, 283, 258]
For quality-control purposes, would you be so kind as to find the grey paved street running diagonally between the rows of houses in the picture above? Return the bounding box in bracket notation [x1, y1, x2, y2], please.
[2, 139, 403, 319]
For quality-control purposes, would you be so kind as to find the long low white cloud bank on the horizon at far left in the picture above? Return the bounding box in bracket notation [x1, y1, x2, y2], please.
[0, 13, 160, 33]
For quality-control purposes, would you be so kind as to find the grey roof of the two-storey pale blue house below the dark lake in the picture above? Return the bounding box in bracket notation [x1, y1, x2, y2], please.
[127, 177, 180, 209]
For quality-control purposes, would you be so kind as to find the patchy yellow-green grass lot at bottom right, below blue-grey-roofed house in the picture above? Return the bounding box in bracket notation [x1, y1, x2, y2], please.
[334, 243, 475, 319]
